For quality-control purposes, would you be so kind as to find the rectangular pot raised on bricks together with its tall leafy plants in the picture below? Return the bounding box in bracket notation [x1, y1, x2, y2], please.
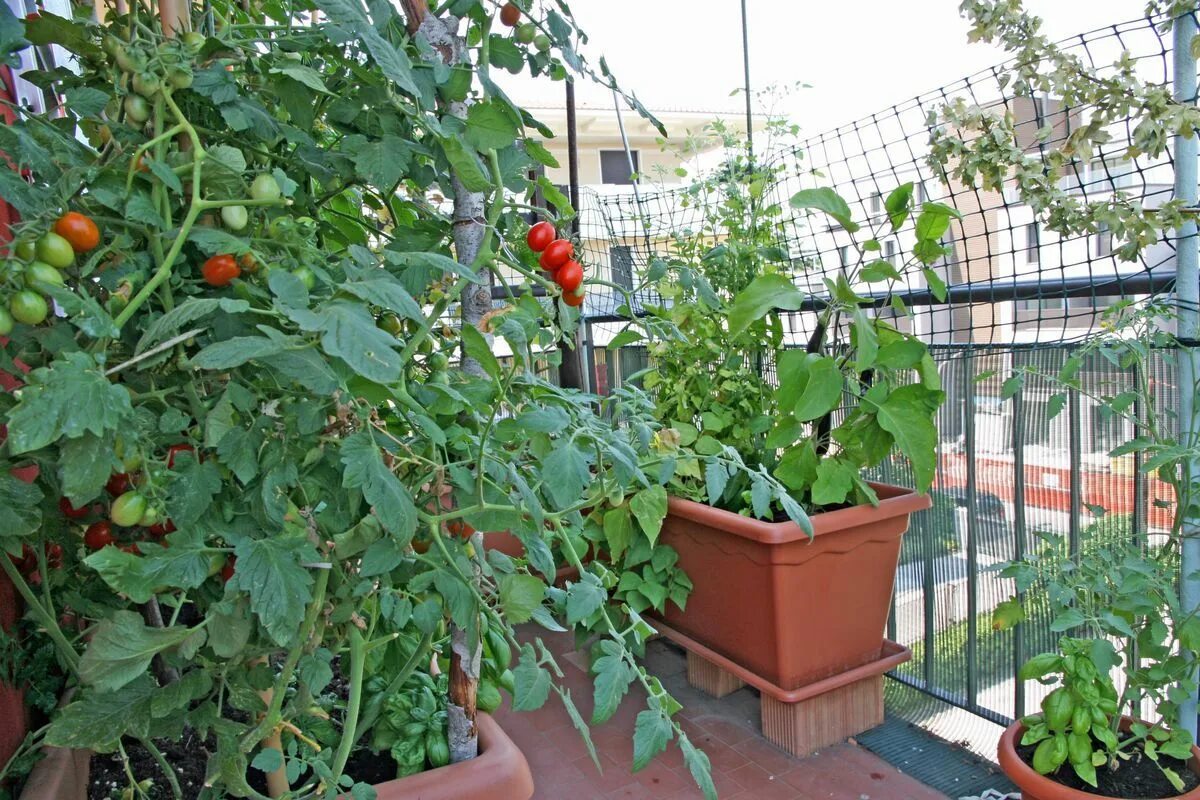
[614, 134, 958, 692]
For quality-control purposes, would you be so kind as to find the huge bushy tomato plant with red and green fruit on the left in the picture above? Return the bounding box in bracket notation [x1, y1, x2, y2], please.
[0, 0, 736, 799]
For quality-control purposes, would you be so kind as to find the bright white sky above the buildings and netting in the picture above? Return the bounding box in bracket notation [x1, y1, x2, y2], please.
[501, 0, 1145, 140]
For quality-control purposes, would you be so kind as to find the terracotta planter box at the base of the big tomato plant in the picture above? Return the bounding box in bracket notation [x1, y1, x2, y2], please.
[20, 714, 533, 800]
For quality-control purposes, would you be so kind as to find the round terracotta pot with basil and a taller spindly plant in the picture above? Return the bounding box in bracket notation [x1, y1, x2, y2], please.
[995, 301, 1200, 800]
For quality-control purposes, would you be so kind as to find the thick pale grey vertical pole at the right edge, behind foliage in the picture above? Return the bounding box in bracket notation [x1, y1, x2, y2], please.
[1171, 12, 1200, 736]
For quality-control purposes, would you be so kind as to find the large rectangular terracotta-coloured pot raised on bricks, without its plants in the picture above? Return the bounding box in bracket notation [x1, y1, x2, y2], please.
[659, 483, 932, 690]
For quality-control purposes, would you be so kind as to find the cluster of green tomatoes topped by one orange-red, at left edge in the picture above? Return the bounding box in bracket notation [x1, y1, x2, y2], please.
[0, 211, 100, 336]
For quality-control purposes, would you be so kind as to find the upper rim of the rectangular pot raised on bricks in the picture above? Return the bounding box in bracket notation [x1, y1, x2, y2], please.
[667, 482, 934, 545]
